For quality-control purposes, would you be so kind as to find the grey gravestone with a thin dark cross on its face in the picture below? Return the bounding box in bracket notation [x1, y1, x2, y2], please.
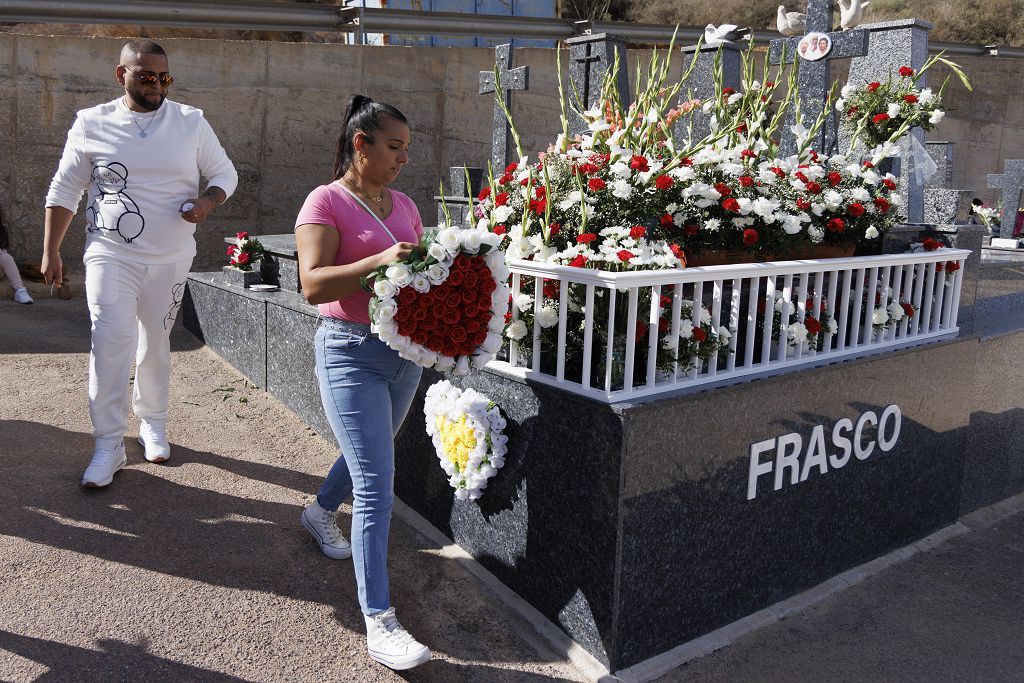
[565, 33, 631, 136]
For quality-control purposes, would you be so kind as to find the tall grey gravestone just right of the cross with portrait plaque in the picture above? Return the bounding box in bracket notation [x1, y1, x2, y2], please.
[841, 19, 932, 223]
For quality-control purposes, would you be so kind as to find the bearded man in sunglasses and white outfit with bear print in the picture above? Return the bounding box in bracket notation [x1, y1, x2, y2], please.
[42, 40, 238, 487]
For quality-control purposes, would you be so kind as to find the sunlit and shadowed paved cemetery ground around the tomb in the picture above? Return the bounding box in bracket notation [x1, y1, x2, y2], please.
[0, 290, 1024, 682]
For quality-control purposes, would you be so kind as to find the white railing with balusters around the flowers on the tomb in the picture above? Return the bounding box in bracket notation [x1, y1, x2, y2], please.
[488, 249, 970, 402]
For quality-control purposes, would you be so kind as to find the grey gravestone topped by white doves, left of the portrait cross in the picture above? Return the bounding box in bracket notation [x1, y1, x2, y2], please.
[673, 43, 743, 143]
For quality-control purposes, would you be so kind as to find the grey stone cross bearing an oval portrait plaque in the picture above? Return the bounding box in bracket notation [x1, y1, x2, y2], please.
[768, 0, 867, 156]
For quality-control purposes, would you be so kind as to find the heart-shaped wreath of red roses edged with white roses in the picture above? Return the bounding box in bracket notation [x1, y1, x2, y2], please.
[370, 227, 509, 375]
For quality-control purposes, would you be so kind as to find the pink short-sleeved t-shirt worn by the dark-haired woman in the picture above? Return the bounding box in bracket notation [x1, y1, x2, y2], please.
[295, 181, 423, 324]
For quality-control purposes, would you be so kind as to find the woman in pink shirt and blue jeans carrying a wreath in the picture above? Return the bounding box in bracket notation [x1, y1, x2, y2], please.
[295, 95, 430, 670]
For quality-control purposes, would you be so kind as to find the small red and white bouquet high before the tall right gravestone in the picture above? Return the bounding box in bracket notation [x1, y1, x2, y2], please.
[836, 54, 971, 148]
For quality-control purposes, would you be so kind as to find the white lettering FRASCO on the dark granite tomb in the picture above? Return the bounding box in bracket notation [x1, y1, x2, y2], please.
[746, 404, 903, 501]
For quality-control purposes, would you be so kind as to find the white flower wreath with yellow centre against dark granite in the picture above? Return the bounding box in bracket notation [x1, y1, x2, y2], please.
[423, 380, 508, 500]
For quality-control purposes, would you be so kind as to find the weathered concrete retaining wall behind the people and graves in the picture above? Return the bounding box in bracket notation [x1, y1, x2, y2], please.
[0, 34, 1024, 269]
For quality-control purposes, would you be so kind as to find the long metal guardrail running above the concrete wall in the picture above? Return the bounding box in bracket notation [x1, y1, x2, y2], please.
[0, 0, 1024, 58]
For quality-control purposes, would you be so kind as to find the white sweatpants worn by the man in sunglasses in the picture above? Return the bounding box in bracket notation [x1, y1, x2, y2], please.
[85, 254, 191, 438]
